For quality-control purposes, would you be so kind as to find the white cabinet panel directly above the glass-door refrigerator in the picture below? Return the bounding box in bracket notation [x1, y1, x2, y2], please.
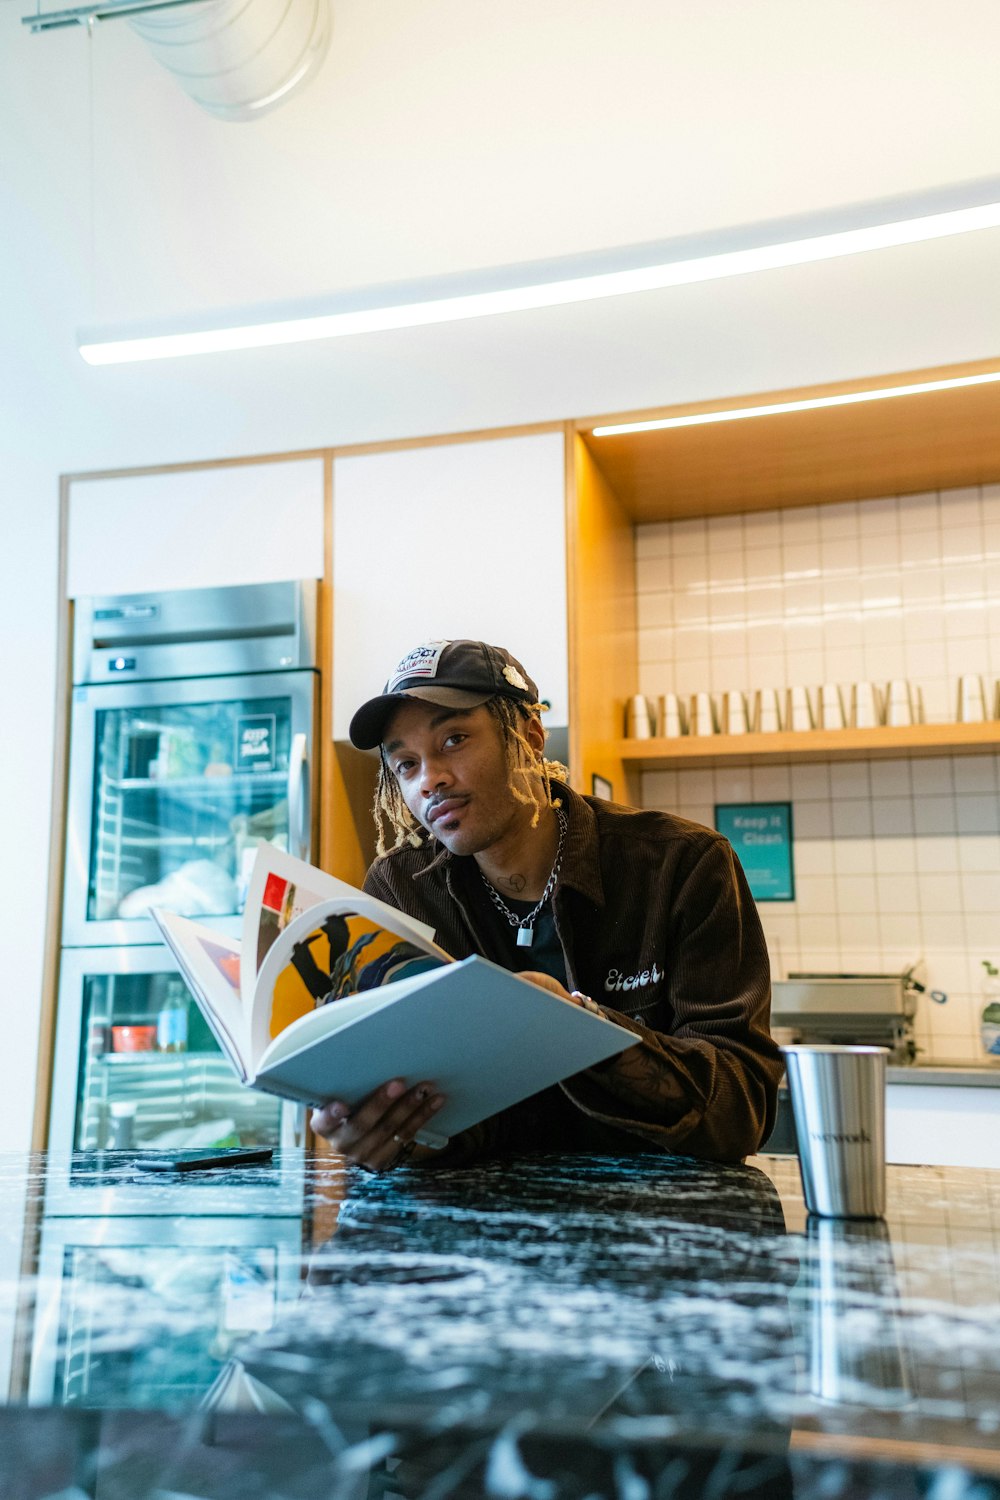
[66, 458, 324, 599]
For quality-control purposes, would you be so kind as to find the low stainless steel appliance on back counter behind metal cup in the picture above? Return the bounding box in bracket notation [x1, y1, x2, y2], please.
[771, 971, 919, 1064]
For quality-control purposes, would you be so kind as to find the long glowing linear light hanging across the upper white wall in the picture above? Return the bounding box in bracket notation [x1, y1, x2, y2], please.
[79, 180, 1000, 365]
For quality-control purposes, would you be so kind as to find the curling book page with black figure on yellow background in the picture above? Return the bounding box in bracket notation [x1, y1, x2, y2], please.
[250, 891, 451, 1070]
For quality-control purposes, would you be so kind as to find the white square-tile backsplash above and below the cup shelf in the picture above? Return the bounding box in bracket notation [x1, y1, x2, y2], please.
[636, 485, 1000, 1062]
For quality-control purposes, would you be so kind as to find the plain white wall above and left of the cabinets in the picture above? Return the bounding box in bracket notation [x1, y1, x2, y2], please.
[0, 0, 1000, 1146]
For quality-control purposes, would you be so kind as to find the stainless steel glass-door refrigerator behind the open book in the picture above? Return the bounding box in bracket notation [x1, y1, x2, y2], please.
[49, 581, 319, 1194]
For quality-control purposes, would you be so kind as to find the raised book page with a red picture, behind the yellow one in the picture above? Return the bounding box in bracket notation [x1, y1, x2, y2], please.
[243, 843, 435, 1013]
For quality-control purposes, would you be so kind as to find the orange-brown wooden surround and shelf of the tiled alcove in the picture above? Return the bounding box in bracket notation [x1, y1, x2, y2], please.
[568, 362, 1000, 803]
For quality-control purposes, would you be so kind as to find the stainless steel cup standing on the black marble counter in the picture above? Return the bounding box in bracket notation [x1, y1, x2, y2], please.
[781, 1046, 889, 1218]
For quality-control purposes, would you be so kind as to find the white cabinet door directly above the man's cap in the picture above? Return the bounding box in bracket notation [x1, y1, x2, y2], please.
[333, 432, 568, 740]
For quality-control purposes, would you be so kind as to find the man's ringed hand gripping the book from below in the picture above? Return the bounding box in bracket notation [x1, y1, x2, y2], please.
[310, 1079, 444, 1172]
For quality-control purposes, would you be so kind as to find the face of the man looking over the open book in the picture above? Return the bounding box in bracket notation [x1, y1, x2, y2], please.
[382, 699, 544, 855]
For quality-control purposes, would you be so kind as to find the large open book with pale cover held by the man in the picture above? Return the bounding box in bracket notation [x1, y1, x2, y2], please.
[151, 843, 636, 1146]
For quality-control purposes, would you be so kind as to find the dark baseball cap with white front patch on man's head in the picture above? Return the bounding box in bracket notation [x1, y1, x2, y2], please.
[348, 641, 538, 750]
